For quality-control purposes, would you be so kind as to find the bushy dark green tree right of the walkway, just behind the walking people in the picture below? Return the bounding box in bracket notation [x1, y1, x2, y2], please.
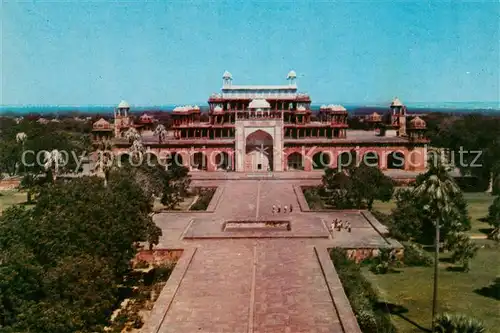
[322, 165, 394, 209]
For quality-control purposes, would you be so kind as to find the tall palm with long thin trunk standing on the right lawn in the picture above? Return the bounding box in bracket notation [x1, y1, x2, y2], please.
[414, 154, 460, 330]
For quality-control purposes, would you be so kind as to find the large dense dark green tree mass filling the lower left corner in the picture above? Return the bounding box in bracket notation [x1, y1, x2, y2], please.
[0, 170, 161, 333]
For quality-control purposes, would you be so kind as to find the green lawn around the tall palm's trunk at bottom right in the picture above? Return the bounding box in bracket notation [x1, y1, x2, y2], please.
[363, 240, 500, 333]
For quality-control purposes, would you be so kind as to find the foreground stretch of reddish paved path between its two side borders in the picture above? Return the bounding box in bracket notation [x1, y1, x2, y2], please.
[159, 240, 343, 333]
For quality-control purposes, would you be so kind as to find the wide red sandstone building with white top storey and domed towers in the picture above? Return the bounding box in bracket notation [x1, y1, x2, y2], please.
[94, 71, 428, 172]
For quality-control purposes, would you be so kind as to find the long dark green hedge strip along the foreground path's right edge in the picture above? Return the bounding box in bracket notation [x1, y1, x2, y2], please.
[330, 249, 396, 333]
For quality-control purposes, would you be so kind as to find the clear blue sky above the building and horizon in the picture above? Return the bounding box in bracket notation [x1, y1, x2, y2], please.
[0, 0, 500, 105]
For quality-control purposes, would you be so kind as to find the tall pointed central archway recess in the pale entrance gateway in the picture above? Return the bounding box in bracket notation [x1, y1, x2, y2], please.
[245, 130, 273, 171]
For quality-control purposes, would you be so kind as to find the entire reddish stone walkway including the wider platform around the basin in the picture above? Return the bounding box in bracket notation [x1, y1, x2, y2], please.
[143, 179, 394, 333]
